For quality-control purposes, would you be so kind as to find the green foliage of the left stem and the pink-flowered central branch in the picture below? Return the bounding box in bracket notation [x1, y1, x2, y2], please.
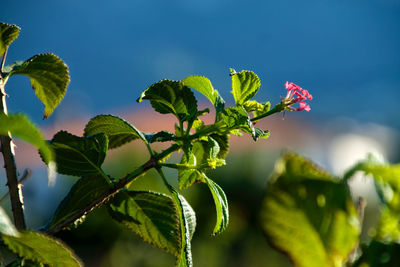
[0, 23, 282, 266]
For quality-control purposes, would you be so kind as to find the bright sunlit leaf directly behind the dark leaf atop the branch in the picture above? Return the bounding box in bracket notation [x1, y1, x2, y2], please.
[182, 75, 225, 113]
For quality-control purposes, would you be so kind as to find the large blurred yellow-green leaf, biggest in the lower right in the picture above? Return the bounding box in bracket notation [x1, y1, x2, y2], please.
[261, 154, 360, 266]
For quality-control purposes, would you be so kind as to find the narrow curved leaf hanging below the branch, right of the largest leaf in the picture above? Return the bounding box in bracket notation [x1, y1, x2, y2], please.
[205, 177, 229, 235]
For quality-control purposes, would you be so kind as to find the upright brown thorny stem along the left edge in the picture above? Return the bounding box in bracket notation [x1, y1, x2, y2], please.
[0, 50, 26, 230]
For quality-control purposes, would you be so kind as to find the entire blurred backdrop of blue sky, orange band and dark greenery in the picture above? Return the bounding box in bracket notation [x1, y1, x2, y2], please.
[0, 0, 400, 266]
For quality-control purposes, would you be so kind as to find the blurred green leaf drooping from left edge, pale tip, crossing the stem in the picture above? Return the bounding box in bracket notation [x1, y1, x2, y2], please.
[0, 114, 54, 164]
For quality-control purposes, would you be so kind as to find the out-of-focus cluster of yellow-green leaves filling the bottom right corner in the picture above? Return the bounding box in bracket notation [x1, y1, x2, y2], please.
[260, 153, 400, 266]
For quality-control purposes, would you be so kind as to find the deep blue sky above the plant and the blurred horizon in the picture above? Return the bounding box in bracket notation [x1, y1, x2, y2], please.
[0, 0, 400, 127]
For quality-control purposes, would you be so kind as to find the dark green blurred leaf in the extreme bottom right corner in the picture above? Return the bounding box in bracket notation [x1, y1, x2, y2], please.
[353, 241, 400, 267]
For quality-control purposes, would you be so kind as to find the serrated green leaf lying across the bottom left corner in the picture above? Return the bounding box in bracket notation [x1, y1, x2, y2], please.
[2, 231, 83, 267]
